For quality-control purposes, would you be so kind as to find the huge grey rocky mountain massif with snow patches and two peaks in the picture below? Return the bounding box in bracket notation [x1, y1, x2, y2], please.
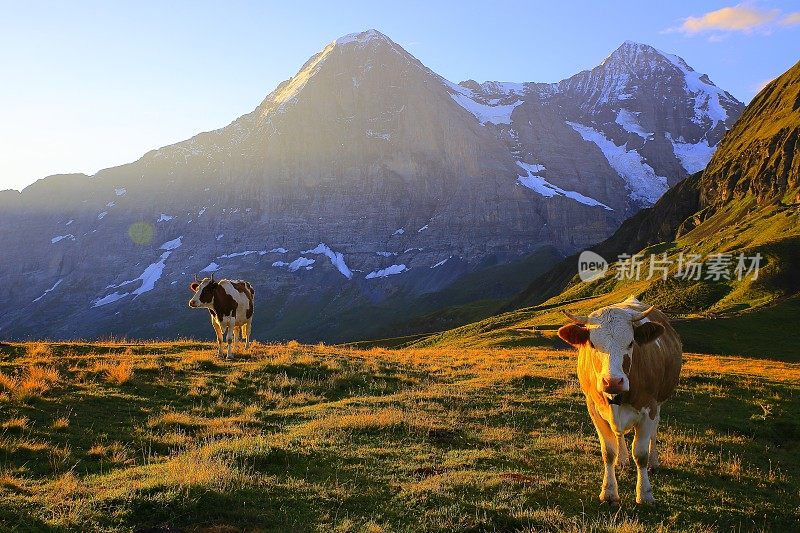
[0, 30, 743, 341]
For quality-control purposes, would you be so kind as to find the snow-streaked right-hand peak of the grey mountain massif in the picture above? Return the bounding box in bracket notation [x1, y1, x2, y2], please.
[462, 41, 744, 212]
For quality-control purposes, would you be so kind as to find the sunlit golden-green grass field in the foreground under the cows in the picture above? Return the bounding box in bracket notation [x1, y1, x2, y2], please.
[0, 342, 800, 532]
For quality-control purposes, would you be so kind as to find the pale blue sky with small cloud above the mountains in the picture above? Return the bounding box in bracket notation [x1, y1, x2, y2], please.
[0, 0, 800, 189]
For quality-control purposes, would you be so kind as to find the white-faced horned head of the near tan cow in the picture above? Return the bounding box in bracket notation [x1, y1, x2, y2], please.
[558, 307, 664, 397]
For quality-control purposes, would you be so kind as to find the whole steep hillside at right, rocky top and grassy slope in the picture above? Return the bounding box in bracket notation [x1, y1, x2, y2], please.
[418, 58, 800, 362]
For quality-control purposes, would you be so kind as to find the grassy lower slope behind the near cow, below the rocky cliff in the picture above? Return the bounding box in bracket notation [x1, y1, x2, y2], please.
[412, 199, 800, 362]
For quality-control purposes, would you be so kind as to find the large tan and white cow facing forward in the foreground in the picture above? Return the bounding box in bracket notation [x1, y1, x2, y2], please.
[558, 296, 683, 504]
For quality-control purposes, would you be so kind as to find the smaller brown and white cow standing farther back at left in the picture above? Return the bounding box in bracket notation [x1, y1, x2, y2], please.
[189, 273, 255, 359]
